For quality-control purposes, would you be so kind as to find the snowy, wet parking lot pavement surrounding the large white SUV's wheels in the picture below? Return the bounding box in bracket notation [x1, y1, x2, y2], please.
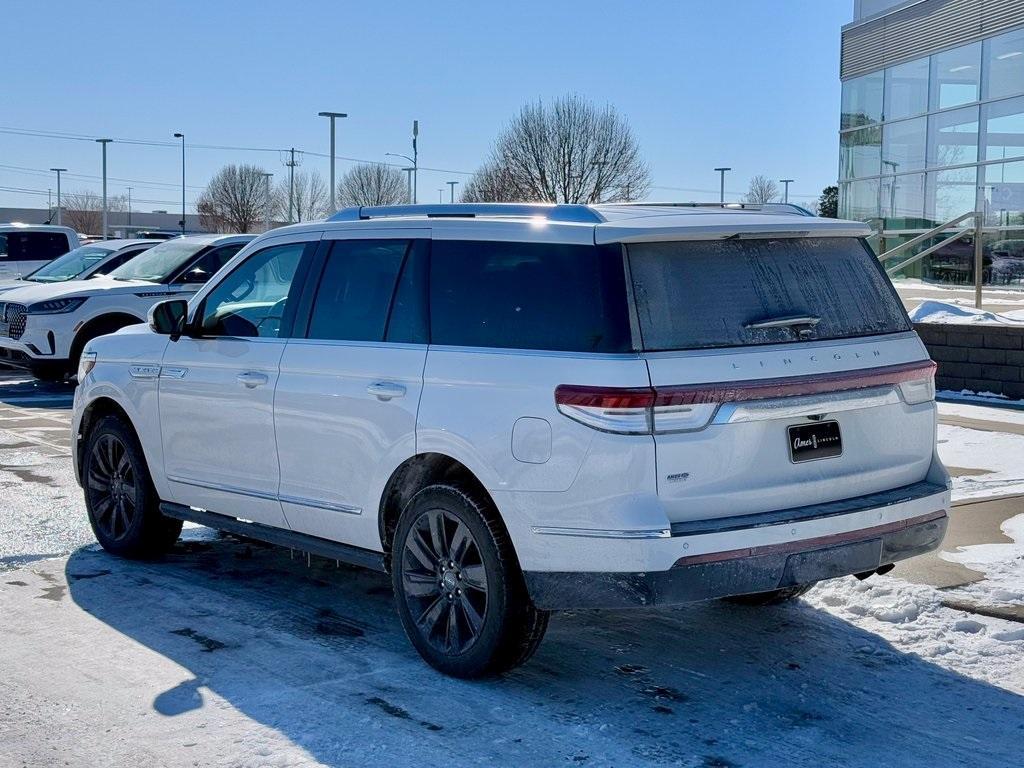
[0, 373, 1024, 768]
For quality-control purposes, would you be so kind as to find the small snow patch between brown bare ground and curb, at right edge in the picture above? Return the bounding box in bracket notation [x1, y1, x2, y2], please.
[939, 514, 1024, 606]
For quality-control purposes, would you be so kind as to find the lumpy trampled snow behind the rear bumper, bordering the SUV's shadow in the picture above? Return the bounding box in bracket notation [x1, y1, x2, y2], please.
[804, 577, 1024, 694]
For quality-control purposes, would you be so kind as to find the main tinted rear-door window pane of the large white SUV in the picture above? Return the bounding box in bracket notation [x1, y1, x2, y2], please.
[307, 240, 410, 341]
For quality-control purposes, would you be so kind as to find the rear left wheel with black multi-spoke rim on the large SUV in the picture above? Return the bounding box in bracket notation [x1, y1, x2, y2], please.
[391, 485, 549, 678]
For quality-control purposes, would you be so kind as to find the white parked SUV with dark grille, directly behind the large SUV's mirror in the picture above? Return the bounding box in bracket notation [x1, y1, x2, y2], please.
[0, 234, 255, 381]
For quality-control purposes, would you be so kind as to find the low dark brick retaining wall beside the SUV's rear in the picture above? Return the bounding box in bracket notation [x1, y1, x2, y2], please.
[913, 323, 1024, 400]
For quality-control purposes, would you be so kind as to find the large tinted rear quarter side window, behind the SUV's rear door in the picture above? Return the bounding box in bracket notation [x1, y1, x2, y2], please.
[430, 240, 631, 352]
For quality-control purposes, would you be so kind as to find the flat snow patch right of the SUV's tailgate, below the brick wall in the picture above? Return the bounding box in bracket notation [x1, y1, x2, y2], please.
[938, 424, 1024, 501]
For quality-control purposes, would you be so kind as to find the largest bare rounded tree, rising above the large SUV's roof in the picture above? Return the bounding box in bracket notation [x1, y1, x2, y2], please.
[463, 94, 650, 203]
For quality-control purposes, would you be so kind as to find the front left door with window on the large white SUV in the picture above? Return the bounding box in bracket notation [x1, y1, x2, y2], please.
[160, 240, 319, 527]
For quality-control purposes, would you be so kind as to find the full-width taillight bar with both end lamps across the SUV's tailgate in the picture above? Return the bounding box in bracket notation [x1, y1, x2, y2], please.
[555, 360, 935, 434]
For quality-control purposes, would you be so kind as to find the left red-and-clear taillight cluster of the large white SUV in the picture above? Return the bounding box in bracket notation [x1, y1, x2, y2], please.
[555, 385, 718, 434]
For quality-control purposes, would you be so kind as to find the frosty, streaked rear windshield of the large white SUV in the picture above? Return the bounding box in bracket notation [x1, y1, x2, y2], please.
[629, 238, 910, 350]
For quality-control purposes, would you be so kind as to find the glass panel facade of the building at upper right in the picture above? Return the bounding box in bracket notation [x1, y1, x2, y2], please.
[840, 28, 1024, 237]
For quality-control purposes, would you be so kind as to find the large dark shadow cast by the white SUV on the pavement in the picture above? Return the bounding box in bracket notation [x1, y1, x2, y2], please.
[67, 531, 1024, 768]
